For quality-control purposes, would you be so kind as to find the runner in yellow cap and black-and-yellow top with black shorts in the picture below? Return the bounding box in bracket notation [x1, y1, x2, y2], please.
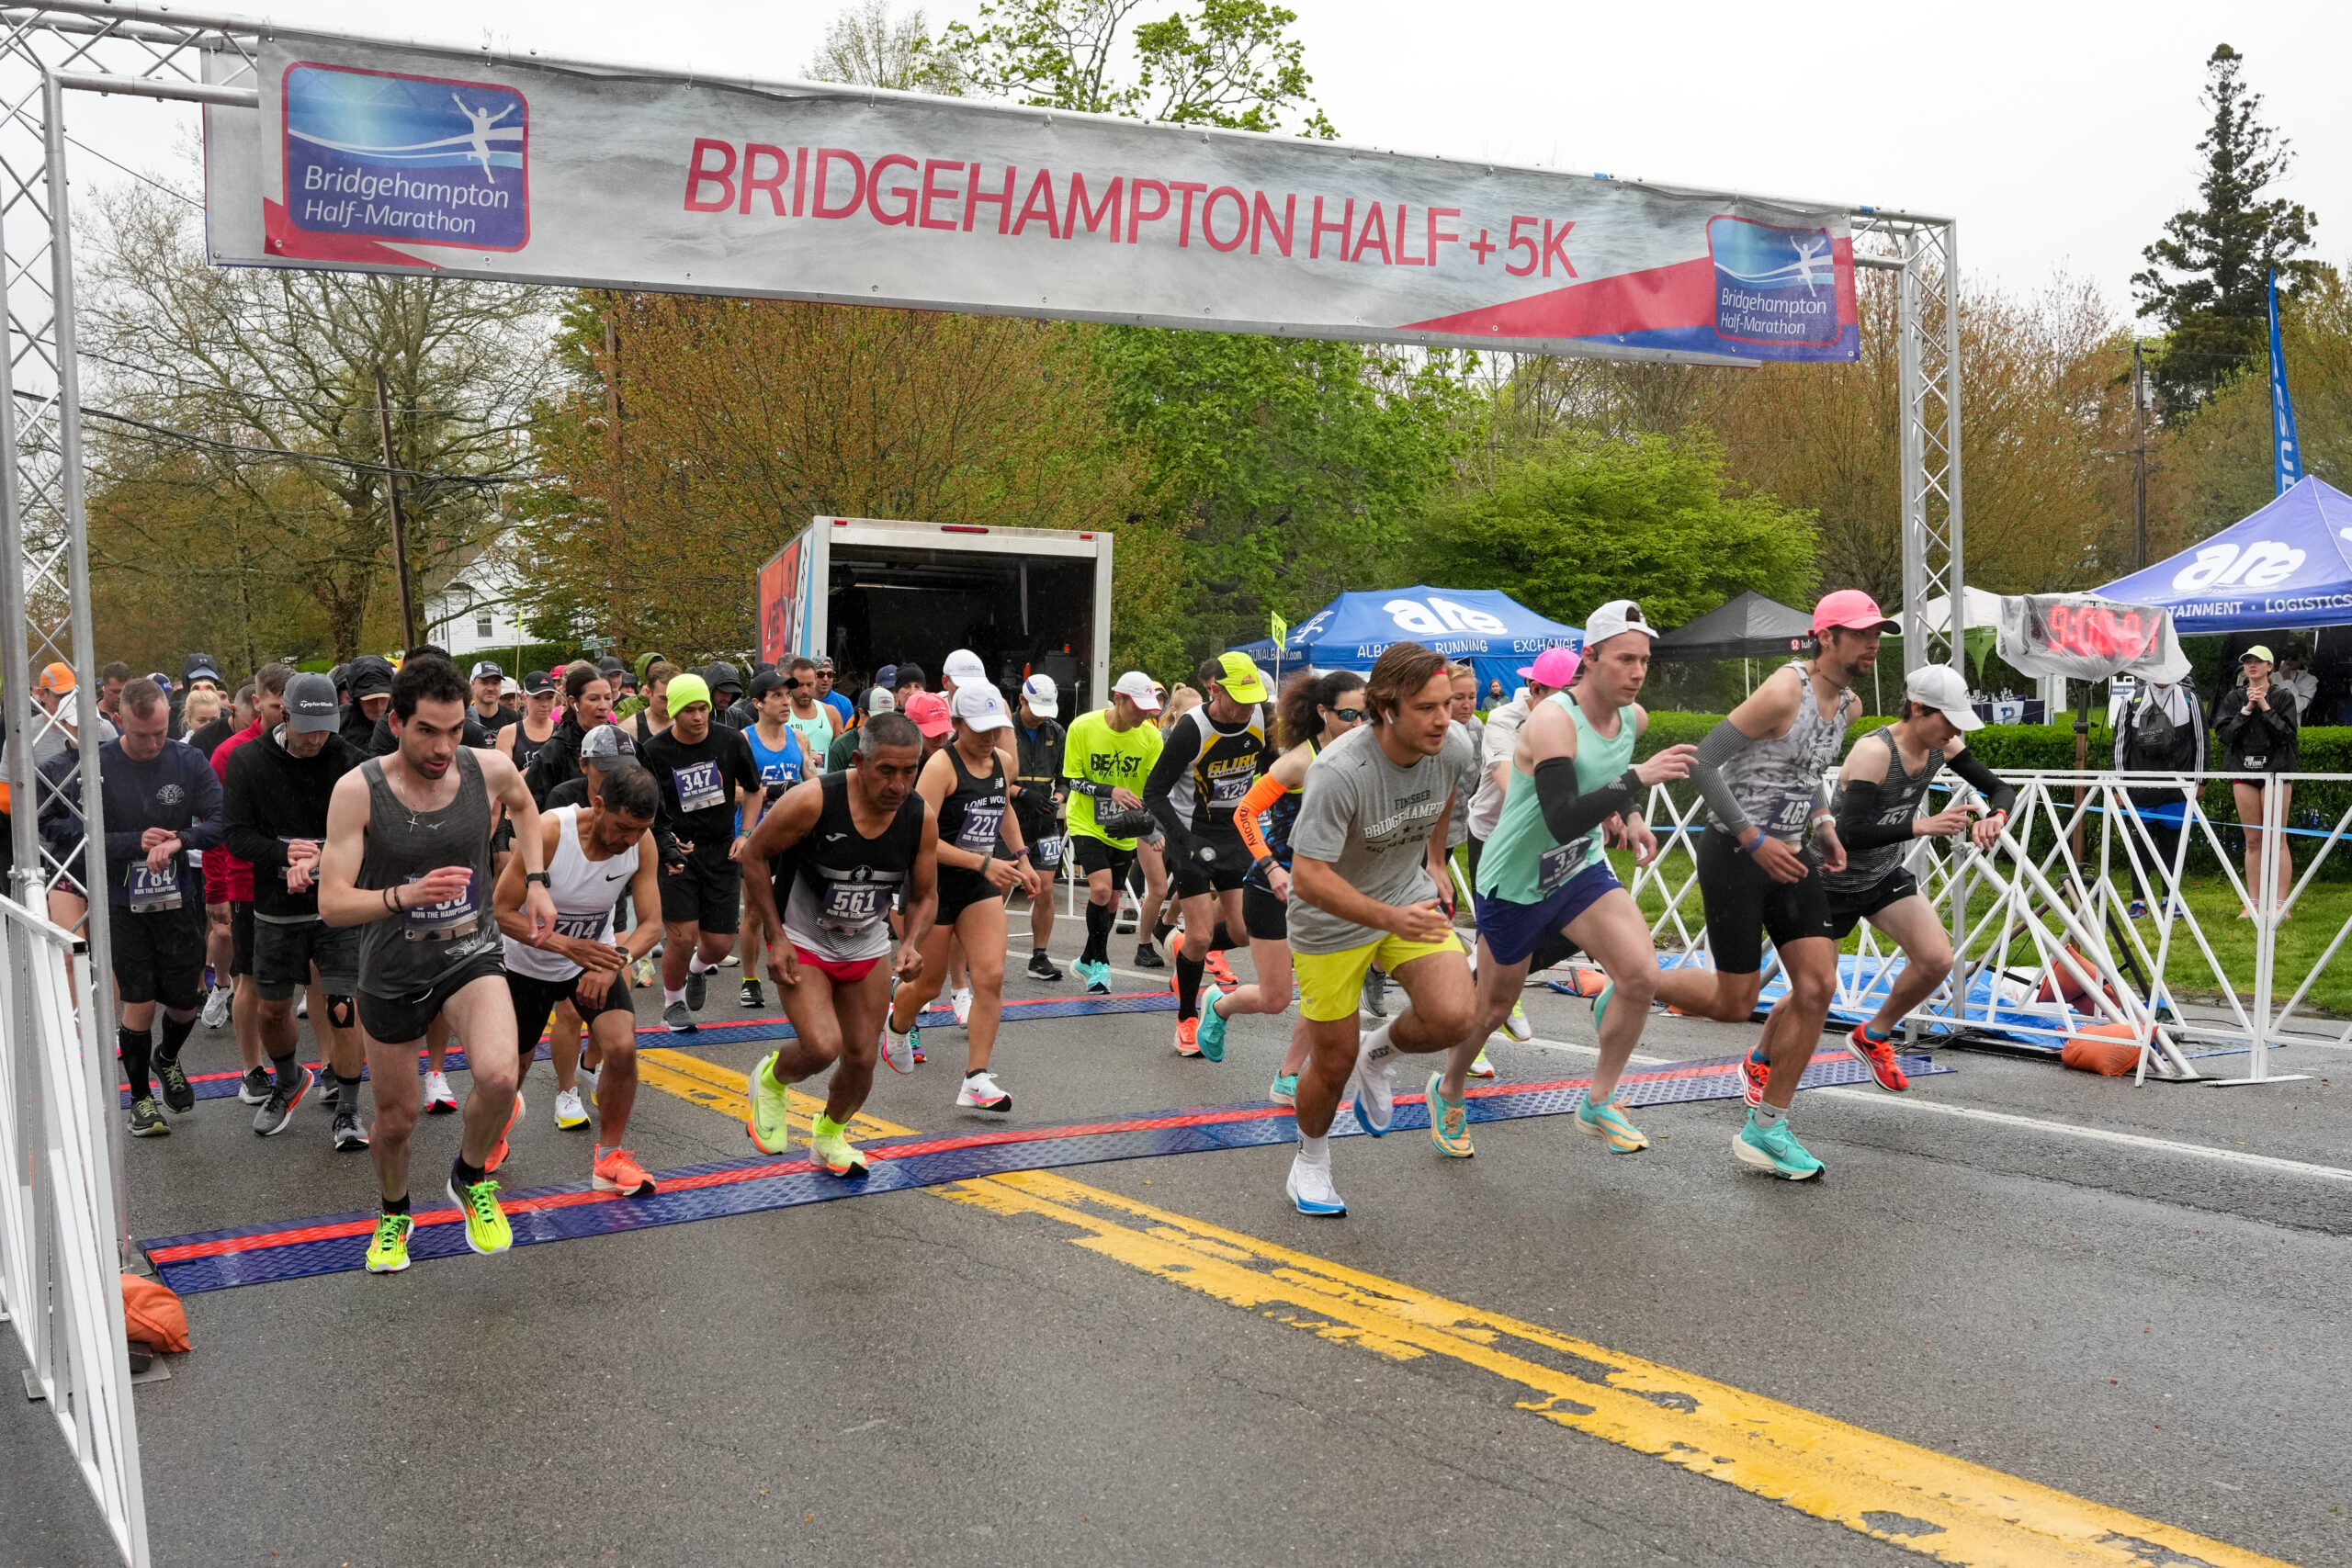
[1143, 653, 1275, 1055]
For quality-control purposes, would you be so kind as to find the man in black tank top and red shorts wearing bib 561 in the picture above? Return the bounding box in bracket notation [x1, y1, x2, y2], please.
[743, 712, 935, 1176]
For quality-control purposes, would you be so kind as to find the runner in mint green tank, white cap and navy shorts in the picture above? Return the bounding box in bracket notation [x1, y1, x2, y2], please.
[1428, 600, 1696, 1156]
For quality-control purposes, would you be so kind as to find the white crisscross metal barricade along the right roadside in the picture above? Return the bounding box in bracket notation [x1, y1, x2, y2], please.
[1633, 771, 2352, 1084]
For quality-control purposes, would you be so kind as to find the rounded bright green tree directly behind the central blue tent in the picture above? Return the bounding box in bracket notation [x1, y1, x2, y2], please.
[1416, 430, 1815, 626]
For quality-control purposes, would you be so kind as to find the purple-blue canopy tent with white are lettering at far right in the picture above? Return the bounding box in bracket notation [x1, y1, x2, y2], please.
[2098, 478, 2352, 637]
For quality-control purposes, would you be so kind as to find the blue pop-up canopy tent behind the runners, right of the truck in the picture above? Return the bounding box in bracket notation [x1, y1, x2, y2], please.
[1238, 588, 1585, 701]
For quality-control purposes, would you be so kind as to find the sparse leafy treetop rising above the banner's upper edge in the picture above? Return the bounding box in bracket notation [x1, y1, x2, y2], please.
[944, 0, 1336, 136]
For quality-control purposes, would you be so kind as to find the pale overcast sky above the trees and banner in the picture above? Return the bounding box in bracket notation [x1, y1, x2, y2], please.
[55, 0, 2352, 317]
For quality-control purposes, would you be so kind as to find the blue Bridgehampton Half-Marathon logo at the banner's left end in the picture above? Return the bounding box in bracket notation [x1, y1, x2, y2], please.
[285, 63, 532, 252]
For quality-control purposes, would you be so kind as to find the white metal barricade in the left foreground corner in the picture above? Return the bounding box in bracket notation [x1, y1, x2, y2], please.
[0, 898, 148, 1565]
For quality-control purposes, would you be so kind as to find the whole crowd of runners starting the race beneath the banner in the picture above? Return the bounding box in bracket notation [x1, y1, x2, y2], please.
[14, 590, 2011, 1272]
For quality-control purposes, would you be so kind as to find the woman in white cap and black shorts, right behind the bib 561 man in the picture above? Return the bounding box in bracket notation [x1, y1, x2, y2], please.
[882, 682, 1042, 1112]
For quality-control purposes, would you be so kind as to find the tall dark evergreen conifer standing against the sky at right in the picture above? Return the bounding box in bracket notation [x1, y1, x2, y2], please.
[2131, 45, 2314, 412]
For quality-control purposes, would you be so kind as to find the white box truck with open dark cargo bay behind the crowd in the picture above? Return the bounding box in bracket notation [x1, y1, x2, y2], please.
[760, 517, 1110, 722]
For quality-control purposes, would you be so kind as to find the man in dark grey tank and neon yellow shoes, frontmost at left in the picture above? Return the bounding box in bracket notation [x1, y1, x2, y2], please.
[318, 656, 555, 1274]
